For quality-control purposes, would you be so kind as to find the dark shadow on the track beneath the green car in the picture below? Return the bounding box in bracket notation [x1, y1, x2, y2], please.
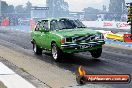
[32, 52, 103, 73]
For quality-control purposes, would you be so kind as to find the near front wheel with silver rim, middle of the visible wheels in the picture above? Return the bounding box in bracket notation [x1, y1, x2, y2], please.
[51, 43, 63, 62]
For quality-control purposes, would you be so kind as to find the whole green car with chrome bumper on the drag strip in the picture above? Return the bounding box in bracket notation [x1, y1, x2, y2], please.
[31, 18, 105, 61]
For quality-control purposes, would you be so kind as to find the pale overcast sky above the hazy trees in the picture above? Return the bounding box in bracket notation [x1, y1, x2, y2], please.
[2, 0, 132, 11]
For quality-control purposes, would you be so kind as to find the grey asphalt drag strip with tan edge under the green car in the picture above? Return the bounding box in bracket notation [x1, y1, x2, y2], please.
[0, 30, 132, 88]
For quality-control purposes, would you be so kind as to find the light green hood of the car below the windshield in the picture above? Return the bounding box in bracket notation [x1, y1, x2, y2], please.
[51, 28, 100, 37]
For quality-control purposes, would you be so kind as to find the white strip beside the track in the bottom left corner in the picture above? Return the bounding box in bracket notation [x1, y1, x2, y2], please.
[0, 62, 36, 88]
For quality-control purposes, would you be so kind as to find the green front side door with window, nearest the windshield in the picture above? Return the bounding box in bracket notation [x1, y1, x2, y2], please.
[41, 20, 50, 49]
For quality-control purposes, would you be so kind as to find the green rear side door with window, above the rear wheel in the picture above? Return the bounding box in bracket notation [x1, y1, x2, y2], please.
[34, 23, 41, 47]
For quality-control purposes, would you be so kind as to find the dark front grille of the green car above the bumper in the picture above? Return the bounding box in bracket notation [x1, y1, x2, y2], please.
[73, 35, 96, 42]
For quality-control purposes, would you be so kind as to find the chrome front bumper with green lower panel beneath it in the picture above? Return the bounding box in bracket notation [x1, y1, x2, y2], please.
[61, 41, 105, 53]
